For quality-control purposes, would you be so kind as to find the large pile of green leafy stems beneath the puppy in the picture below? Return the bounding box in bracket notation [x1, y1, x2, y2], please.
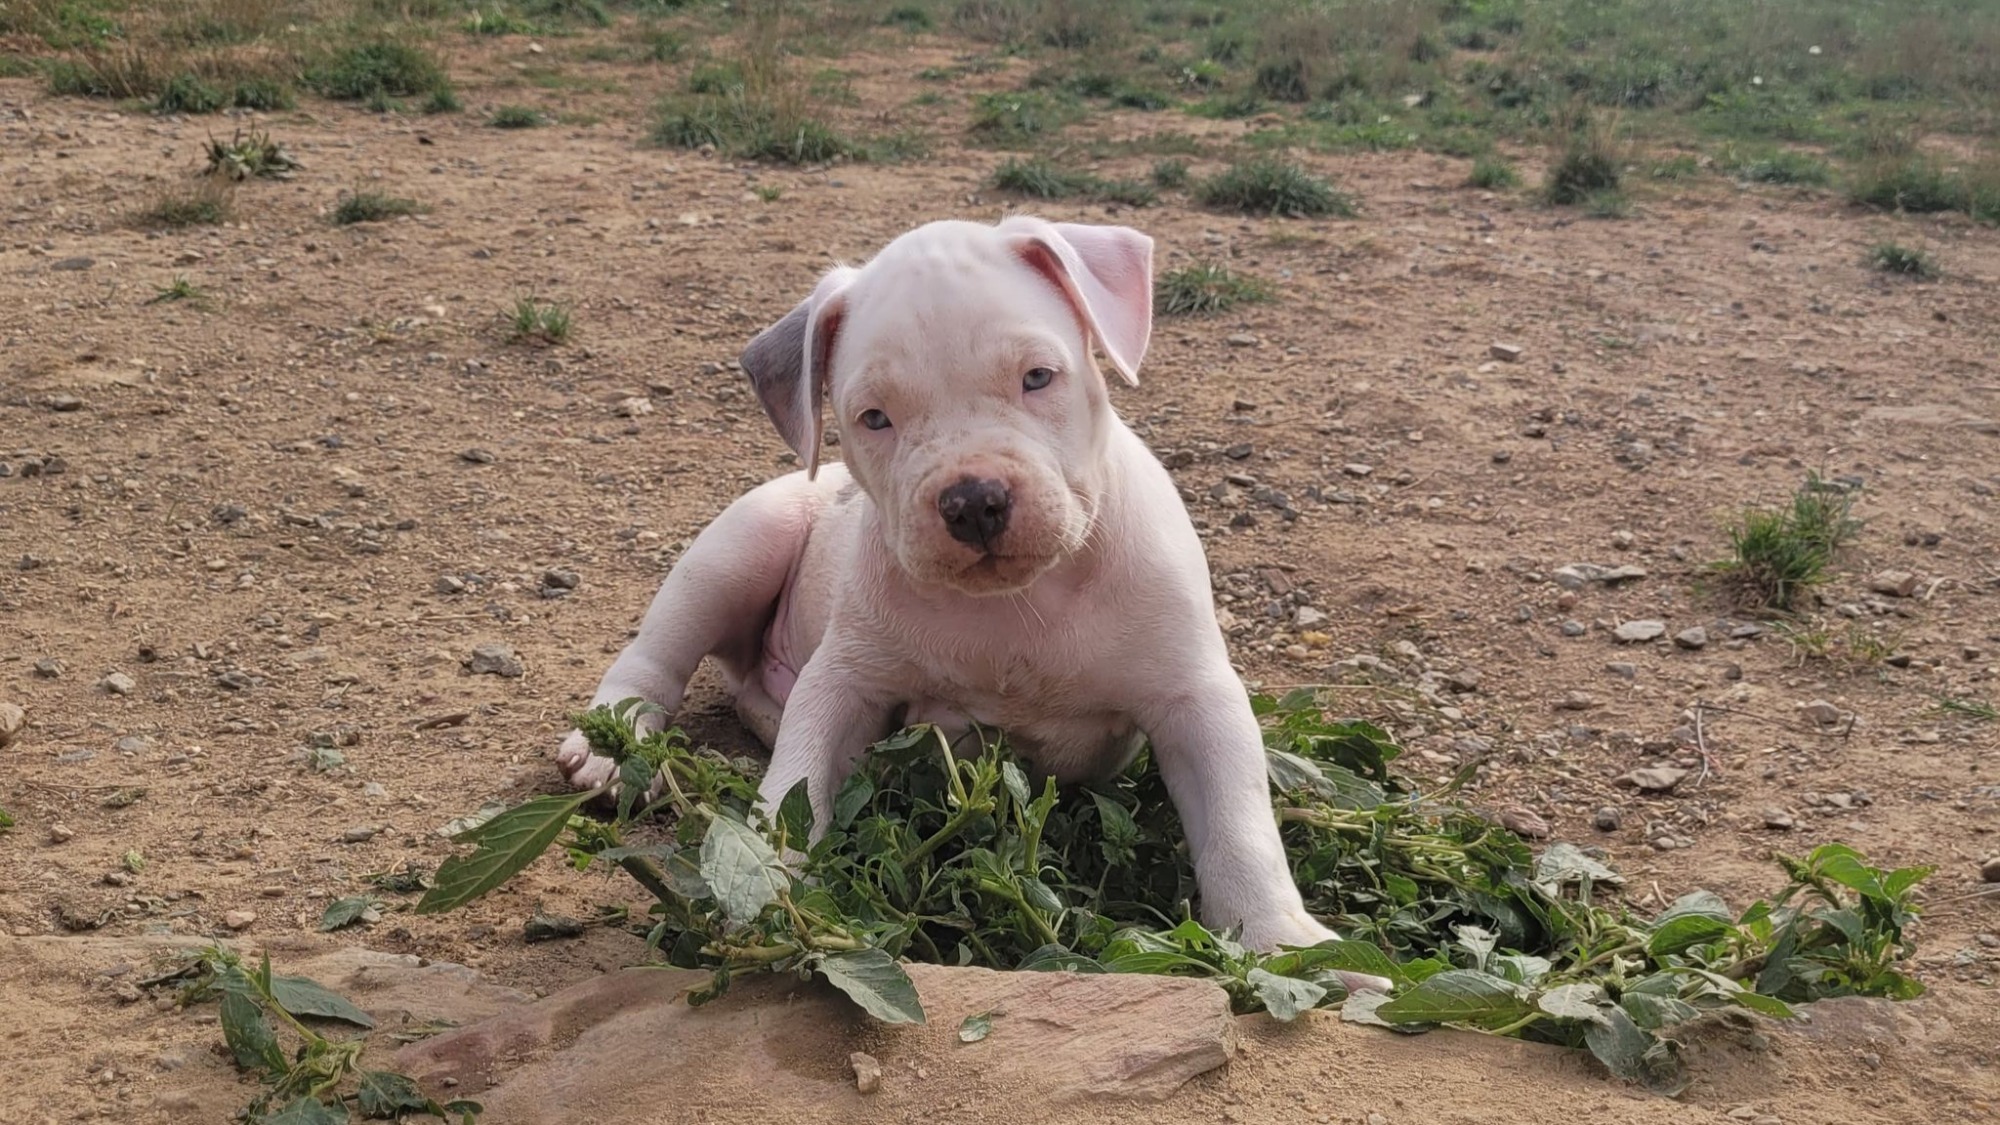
[416, 689, 1928, 1091]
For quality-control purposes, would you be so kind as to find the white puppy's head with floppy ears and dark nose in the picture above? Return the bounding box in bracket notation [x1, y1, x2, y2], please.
[742, 216, 1152, 595]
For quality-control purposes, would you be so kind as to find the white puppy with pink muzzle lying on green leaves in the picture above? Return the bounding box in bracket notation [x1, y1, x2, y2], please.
[558, 216, 1386, 987]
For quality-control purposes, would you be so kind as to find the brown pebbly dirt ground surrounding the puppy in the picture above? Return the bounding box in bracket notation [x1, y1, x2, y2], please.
[0, 26, 2000, 1125]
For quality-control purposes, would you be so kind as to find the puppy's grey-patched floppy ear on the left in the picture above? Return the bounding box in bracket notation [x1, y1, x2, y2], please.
[738, 266, 856, 476]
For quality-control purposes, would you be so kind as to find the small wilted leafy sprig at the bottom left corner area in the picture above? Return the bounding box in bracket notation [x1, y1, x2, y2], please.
[163, 945, 480, 1125]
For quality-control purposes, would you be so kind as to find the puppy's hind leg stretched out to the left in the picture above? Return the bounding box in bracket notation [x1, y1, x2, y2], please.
[556, 472, 818, 789]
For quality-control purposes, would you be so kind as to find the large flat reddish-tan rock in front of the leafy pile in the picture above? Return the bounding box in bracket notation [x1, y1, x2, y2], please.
[394, 952, 1236, 1125]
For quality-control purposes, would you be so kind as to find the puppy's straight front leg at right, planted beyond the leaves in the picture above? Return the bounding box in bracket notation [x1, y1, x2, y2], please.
[1140, 665, 1390, 991]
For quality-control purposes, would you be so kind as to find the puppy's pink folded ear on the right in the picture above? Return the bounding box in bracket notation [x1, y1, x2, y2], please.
[1000, 216, 1152, 386]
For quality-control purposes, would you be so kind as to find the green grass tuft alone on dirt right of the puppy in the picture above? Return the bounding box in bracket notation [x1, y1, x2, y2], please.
[1712, 472, 1862, 613]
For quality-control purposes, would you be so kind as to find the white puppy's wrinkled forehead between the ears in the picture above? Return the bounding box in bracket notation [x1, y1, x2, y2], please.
[834, 224, 1082, 390]
